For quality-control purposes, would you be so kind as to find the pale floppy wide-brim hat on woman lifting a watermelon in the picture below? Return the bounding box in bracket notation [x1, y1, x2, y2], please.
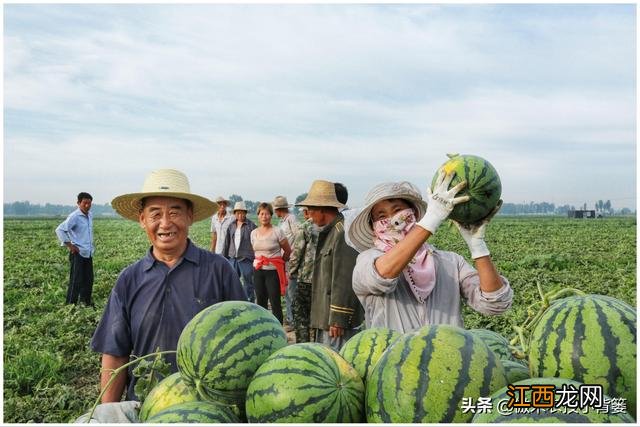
[347, 181, 427, 252]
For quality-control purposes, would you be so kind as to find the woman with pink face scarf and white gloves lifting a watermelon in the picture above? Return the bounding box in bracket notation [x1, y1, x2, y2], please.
[348, 174, 513, 333]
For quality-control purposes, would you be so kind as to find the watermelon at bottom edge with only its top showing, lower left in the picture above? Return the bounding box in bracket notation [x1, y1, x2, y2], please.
[146, 401, 240, 424]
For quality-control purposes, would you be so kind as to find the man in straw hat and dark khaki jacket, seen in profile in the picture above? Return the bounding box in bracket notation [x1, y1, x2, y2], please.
[298, 180, 363, 350]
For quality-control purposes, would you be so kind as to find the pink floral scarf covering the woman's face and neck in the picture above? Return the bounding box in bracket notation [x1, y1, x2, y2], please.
[373, 209, 436, 304]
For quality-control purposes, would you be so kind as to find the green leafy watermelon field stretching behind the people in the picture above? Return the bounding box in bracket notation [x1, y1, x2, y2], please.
[3, 216, 637, 423]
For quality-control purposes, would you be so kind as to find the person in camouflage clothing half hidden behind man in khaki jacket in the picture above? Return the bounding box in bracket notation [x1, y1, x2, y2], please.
[289, 207, 318, 343]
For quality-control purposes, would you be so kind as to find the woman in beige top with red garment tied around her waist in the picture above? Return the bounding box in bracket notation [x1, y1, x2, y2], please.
[251, 202, 291, 324]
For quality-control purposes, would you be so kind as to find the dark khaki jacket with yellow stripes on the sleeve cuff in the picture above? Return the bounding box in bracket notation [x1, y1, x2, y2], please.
[311, 214, 364, 330]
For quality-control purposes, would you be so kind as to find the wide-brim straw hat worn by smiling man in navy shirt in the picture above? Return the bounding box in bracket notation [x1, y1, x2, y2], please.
[111, 169, 218, 222]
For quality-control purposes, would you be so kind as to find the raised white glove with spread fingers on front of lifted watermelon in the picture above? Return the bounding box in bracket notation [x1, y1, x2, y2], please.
[417, 169, 469, 234]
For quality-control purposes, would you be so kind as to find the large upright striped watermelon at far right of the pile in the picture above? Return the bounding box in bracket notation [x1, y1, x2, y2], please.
[529, 295, 636, 414]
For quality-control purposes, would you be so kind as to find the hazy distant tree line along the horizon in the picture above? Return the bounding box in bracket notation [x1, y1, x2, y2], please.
[4, 197, 635, 217]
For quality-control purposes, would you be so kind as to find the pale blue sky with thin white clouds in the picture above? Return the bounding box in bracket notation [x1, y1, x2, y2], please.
[3, 4, 637, 210]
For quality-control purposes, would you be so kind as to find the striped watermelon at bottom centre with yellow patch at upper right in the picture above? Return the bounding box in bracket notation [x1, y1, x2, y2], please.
[246, 343, 364, 423]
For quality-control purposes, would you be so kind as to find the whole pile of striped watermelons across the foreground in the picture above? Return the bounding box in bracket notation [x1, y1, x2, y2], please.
[140, 295, 636, 424]
